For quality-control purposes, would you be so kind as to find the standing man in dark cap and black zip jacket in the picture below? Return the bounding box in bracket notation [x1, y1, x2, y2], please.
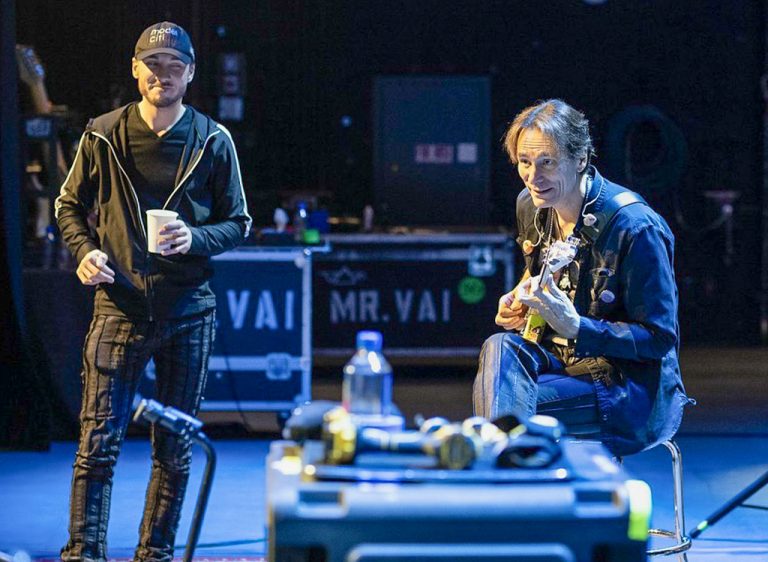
[56, 22, 251, 561]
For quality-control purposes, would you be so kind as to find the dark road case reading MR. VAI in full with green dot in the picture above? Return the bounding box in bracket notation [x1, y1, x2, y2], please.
[313, 234, 513, 362]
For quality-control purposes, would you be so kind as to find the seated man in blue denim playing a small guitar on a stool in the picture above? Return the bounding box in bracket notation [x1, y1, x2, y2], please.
[473, 100, 689, 455]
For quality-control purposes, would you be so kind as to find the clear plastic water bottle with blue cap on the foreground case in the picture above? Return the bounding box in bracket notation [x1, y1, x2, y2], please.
[341, 331, 403, 428]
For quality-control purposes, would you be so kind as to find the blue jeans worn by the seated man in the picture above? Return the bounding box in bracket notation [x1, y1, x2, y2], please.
[472, 332, 610, 435]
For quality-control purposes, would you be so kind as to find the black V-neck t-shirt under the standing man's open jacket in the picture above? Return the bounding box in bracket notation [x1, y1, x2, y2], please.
[125, 105, 192, 221]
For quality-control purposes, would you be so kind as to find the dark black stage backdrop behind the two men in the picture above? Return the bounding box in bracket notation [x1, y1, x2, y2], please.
[17, 0, 765, 344]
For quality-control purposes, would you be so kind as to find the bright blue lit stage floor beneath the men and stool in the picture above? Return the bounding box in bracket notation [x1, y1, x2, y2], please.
[0, 435, 768, 562]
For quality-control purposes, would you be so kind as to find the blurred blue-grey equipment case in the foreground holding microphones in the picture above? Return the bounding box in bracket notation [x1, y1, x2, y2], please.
[267, 440, 651, 562]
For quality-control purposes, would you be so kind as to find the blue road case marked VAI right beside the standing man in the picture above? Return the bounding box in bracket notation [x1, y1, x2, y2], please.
[201, 247, 312, 412]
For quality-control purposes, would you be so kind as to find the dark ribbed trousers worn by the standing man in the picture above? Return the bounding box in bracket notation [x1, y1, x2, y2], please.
[61, 311, 214, 562]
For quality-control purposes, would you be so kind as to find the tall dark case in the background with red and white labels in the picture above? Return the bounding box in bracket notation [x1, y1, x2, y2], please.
[373, 76, 493, 226]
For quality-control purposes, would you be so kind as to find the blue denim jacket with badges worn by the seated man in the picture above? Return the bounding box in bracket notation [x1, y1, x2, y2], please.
[517, 168, 692, 455]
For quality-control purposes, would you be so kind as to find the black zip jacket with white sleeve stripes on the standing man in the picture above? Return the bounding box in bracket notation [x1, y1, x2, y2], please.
[56, 104, 251, 320]
